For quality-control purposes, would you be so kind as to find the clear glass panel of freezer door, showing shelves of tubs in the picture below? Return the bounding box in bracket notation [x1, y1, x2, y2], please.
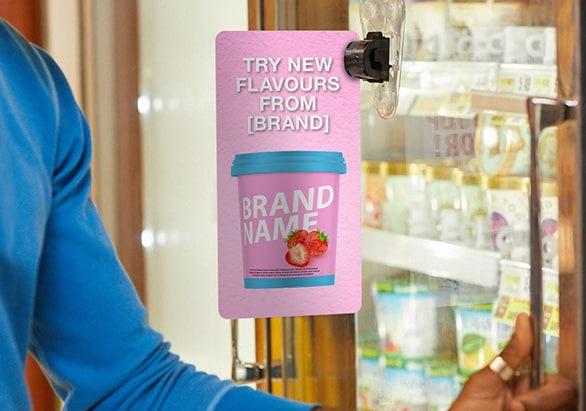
[349, 0, 575, 410]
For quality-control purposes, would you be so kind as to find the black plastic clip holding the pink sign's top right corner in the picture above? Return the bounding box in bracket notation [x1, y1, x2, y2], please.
[344, 31, 390, 83]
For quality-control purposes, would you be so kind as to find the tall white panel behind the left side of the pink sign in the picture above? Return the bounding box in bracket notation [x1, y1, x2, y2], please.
[139, 0, 254, 378]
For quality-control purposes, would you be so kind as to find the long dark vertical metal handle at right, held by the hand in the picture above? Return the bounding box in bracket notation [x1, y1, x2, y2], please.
[527, 97, 578, 388]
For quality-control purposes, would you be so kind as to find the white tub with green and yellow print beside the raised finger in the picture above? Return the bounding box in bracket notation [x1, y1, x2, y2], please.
[454, 303, 497, 377]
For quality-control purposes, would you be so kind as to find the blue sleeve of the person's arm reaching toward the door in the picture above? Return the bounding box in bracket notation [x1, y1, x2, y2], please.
[29, 33, 318, 411]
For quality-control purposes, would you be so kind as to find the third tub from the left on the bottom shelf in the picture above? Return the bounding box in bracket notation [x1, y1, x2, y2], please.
[425, 358, 460, 411]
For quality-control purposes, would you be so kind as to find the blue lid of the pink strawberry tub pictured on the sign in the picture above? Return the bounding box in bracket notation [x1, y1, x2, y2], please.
[231, 151, 346, 176]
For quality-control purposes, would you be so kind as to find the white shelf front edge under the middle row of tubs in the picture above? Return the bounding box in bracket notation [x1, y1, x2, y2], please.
[362, 227, 501, 287]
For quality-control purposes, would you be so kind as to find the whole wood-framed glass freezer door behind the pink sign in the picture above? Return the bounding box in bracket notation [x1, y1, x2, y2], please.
[249, 0, 586, 410]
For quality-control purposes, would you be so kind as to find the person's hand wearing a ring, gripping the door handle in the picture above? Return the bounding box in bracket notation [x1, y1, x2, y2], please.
[451, 314, 576, 411]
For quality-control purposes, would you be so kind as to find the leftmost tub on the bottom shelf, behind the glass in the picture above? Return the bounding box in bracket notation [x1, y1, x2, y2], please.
[357, 345, 384, 410]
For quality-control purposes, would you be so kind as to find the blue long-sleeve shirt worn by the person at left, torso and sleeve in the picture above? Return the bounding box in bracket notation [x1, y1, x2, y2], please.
[0, 20, 310, 411]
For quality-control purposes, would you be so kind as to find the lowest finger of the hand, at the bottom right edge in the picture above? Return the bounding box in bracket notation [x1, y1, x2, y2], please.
[510, 378, 577, 411]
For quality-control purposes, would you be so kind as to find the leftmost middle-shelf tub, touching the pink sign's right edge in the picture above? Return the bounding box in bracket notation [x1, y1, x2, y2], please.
[362, 161, 386, 228]
